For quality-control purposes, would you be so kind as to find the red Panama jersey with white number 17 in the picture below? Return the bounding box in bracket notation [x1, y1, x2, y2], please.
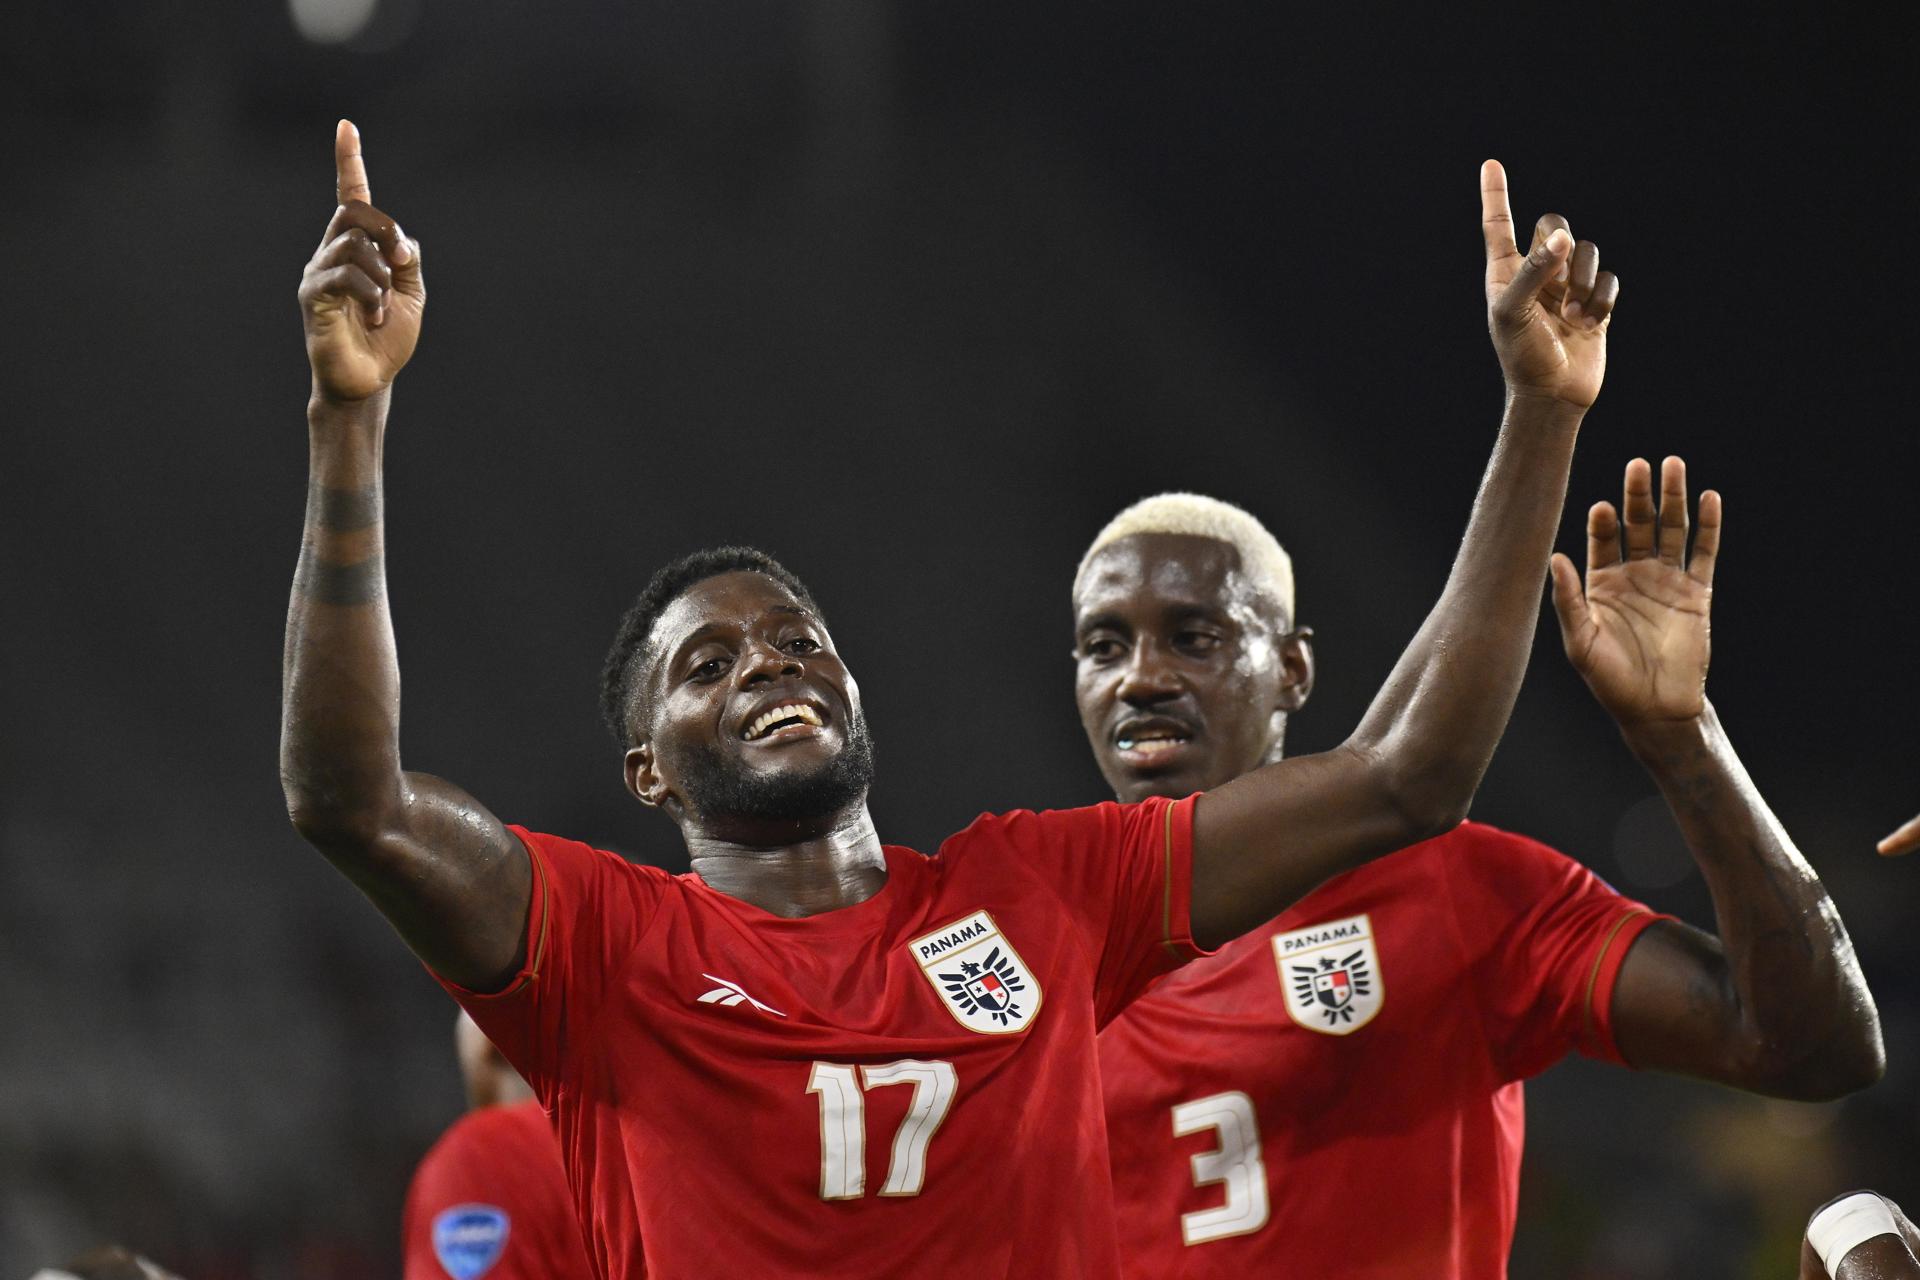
[449, 800, 1198, 1280]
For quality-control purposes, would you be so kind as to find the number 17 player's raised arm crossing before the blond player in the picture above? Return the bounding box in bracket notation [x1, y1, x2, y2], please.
[1192, 161, 1619, 946]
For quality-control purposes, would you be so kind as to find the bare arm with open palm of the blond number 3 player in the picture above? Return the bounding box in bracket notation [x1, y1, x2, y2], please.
[1553, 459, 1885, 1100]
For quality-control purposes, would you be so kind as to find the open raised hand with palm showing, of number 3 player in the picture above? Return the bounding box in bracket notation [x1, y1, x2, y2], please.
[1553, 459, 1720, 727]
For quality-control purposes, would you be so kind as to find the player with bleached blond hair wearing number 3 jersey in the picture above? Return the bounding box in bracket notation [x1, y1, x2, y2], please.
[1073, 483, 1882, 1280]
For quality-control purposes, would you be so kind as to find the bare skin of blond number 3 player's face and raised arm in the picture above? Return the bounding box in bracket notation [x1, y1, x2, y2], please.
[1075, 459, 1884, 1098]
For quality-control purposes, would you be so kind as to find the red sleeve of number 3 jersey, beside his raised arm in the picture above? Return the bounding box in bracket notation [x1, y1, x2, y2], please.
[1442, 823, 1670, 1080]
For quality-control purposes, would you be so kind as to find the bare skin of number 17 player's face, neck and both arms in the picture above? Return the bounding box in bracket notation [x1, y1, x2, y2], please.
[280, 135, 1619, 974]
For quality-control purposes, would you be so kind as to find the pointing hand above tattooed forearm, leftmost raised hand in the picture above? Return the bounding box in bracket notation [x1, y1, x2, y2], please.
[300, 121, 426, 401]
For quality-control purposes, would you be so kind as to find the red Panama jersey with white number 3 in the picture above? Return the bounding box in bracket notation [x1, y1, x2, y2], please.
[1100, 823, 1657, 1280]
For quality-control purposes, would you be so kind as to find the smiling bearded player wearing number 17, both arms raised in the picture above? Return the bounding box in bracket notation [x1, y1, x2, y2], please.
[280, 123, 1617, 1278]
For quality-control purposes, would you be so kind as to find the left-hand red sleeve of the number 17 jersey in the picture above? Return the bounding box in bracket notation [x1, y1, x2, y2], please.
[434, 827, 672, 1107]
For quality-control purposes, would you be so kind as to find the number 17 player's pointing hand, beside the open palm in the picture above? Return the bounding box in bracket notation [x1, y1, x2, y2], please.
[1480, 159, 1620, 409]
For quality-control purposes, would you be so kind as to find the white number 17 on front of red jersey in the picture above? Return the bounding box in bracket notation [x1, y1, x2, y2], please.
[806, 1057, 958, 1199]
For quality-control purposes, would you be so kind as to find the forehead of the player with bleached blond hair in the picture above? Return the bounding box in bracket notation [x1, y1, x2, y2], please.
[1073, 533, 1273, 618]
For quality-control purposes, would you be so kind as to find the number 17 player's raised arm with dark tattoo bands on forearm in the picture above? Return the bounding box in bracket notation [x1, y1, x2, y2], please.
[280, 121, 532, 990]
